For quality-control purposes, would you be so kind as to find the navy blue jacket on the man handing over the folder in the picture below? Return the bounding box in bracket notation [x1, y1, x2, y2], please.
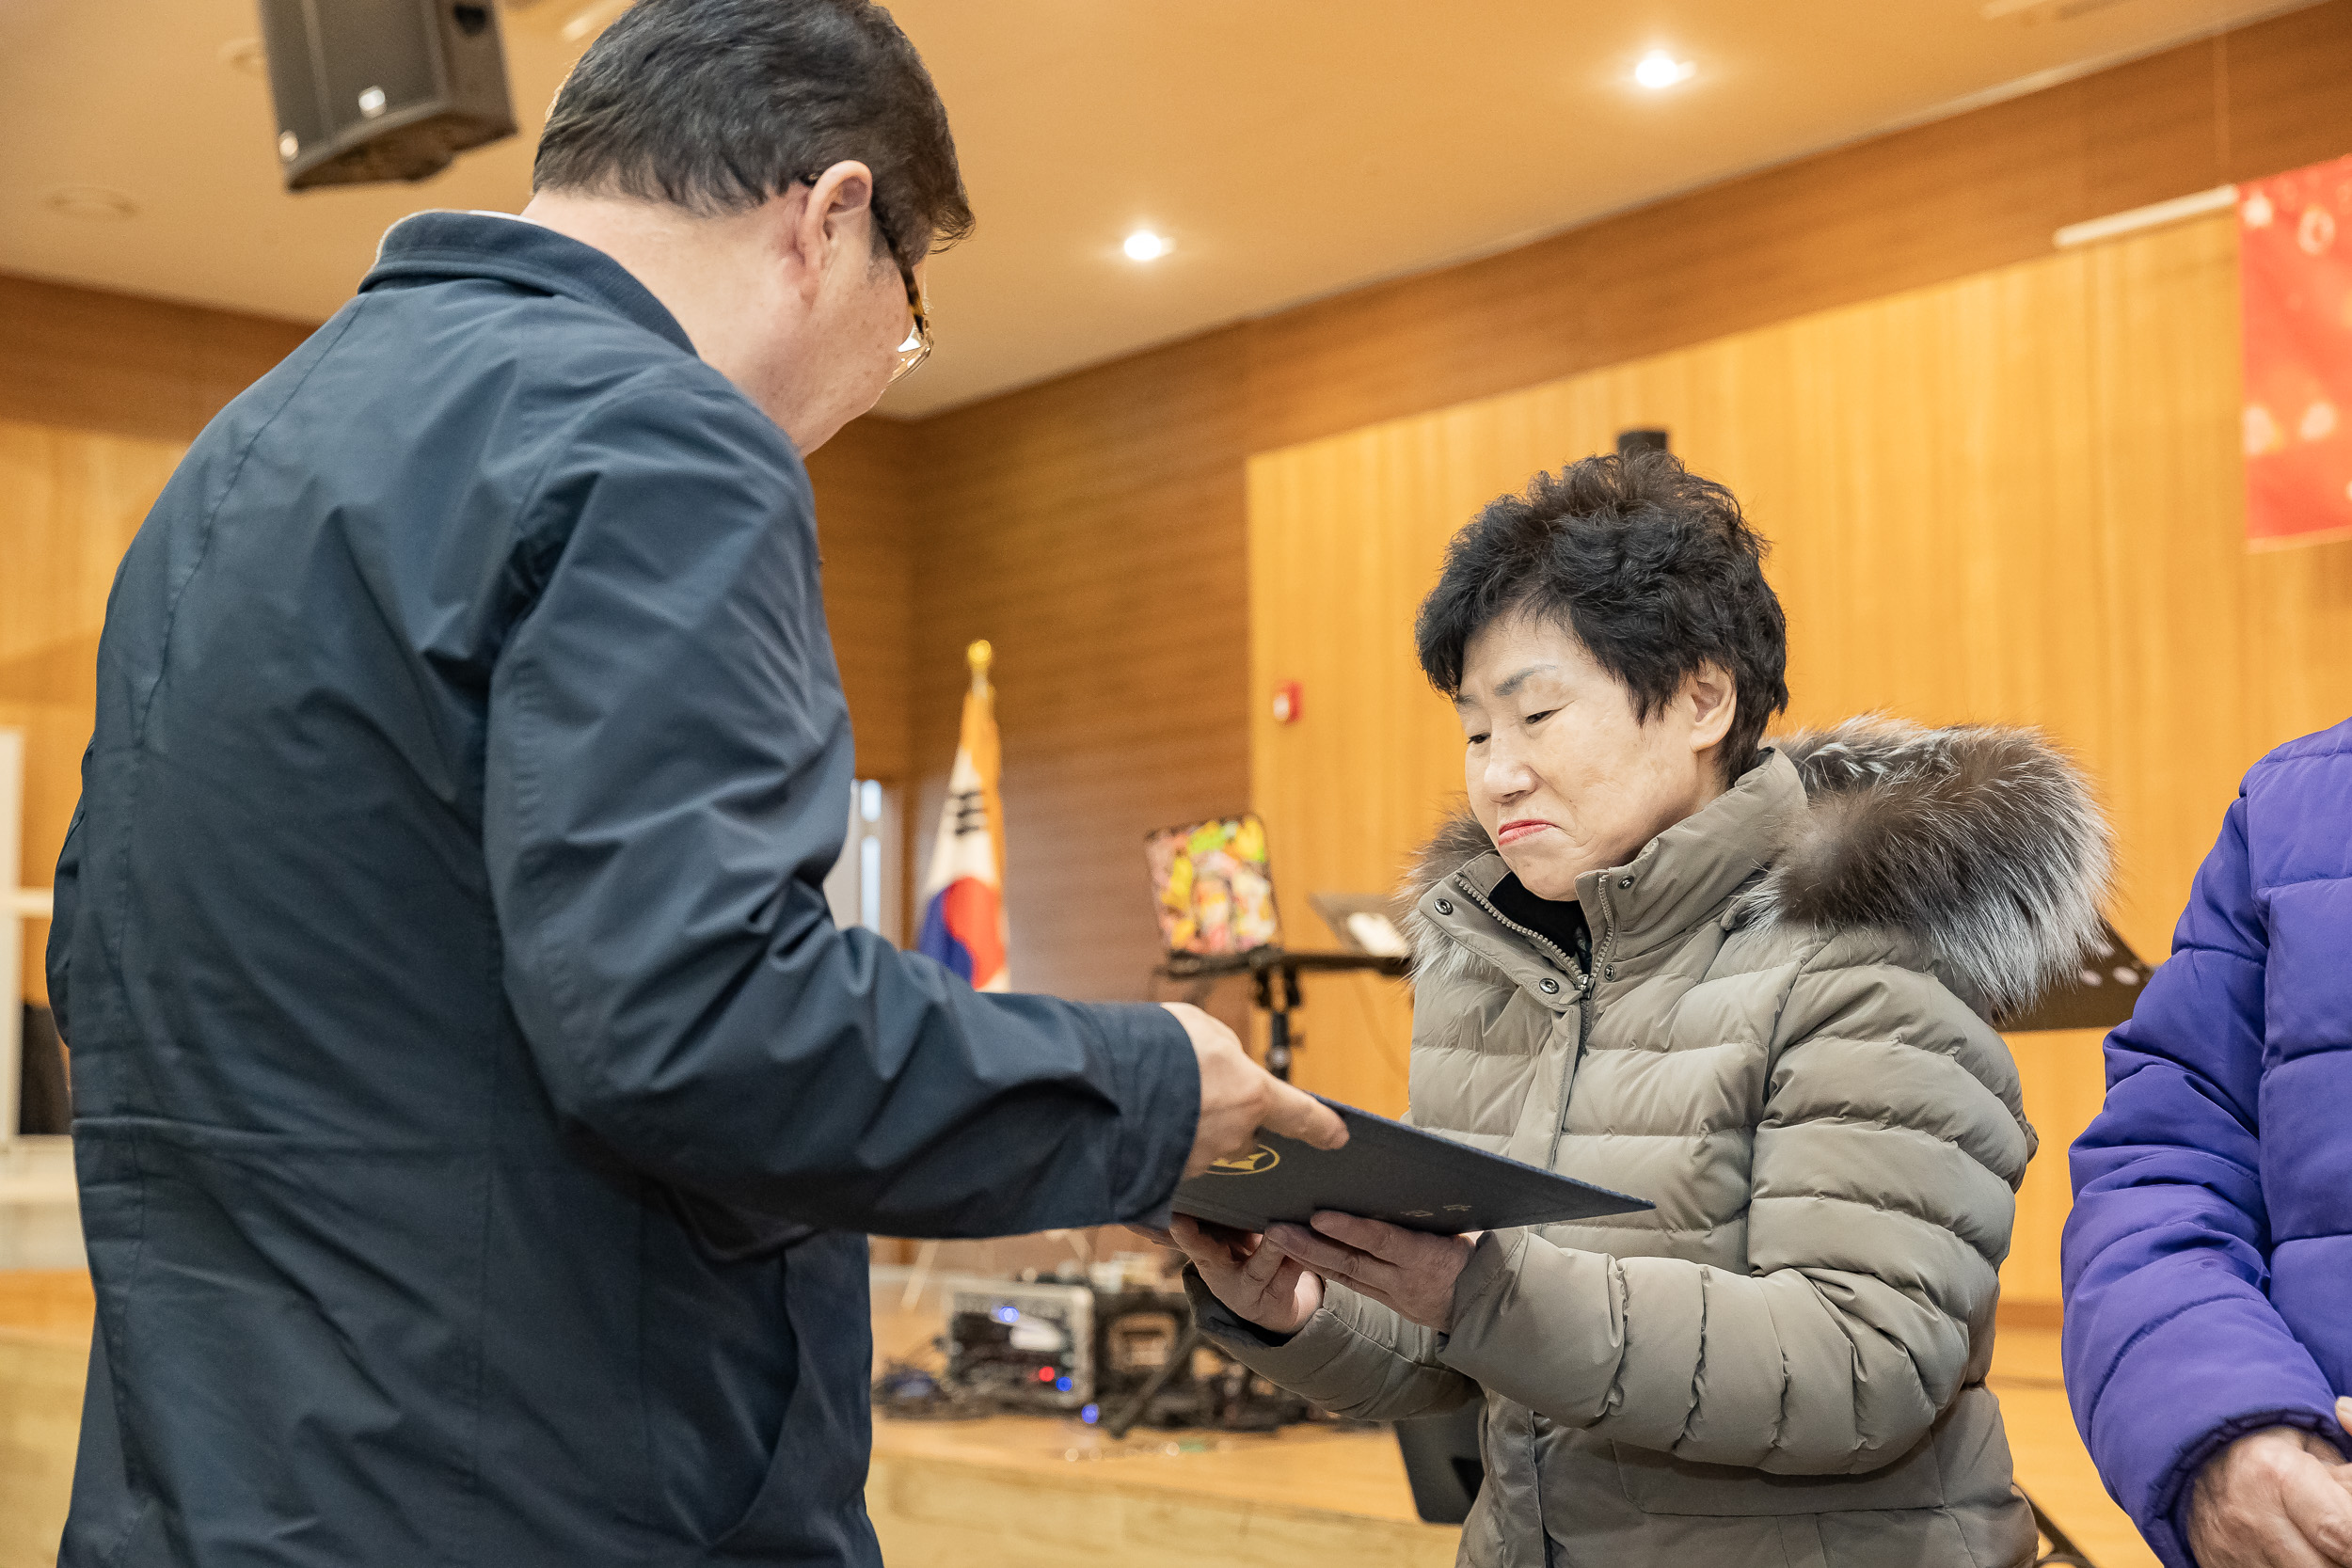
[50, 214, 1200, 1568]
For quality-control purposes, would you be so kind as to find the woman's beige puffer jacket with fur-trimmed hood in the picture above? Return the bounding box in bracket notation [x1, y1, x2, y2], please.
[1193, 720, 2107, 1568]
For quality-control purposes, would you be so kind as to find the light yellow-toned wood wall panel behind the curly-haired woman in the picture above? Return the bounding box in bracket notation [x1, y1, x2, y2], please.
[1249, 214, 2352, 1300]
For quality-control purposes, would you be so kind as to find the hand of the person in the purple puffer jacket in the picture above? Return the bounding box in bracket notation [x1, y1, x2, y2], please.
[2190, 1402, 2352, 1568]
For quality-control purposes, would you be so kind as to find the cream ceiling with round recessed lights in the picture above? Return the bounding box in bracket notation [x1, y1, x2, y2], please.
[0, 0, 2296, 414]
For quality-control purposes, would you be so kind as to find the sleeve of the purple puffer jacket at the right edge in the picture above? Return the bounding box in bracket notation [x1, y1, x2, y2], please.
[2063, 797, 2336, 1568]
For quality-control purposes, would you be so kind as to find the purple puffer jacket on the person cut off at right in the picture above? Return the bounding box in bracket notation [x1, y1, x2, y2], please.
[2065, 721, 2352, 1568]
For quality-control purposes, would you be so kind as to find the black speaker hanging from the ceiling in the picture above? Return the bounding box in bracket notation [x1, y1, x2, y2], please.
[262, 0, 516, 190]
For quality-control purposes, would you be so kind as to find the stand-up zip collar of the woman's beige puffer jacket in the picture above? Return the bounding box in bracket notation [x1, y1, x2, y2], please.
[1414, 750, 1804, 1004]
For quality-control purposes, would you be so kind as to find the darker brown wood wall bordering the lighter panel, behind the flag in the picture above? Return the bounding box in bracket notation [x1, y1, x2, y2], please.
[911, 0, 2352, 1020]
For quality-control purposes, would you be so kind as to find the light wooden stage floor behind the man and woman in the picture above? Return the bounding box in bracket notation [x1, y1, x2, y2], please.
[0, 1272, 2157, 1568]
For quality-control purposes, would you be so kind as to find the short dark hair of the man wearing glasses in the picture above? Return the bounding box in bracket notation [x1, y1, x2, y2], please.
[532, 0, 972, 265]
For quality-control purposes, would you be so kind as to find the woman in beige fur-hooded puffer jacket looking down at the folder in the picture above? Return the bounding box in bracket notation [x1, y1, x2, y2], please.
[1176, 453, 2107, 1568]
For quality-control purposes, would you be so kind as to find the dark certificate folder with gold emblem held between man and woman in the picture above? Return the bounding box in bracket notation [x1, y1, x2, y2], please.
[1176, 1101, 1651, 1237]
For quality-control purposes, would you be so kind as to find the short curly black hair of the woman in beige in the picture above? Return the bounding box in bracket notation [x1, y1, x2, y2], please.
[1414, 451, 1788, 783]
